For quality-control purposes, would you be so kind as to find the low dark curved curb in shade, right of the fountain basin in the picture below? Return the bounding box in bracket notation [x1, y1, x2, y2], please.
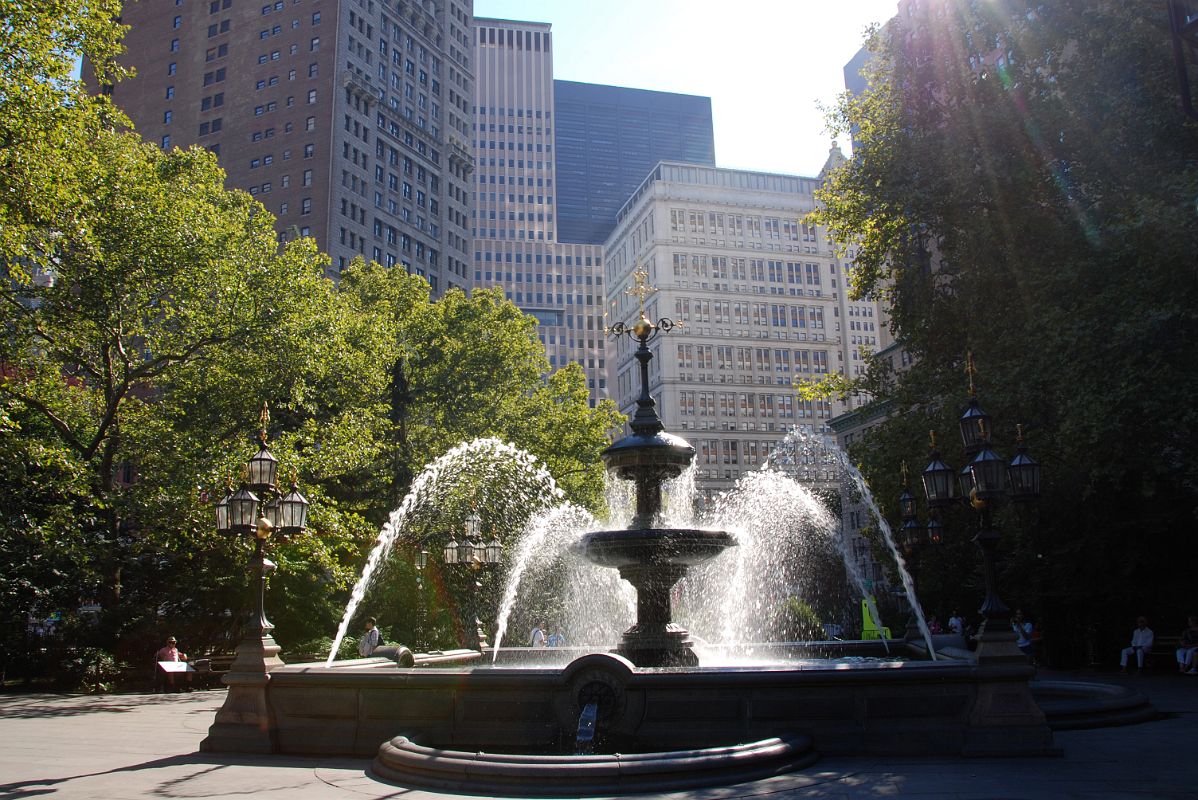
[1029, 680, 1160, 731]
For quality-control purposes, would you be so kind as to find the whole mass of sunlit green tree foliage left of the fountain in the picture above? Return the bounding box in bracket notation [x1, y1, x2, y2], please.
[0, 7, 622, 670]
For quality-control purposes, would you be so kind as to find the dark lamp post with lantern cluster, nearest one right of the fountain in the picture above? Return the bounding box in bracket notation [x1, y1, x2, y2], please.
[922, 354, 1040, 663]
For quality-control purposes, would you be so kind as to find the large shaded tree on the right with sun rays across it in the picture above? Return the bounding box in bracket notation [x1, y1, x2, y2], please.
[815, 0, 1198, 653]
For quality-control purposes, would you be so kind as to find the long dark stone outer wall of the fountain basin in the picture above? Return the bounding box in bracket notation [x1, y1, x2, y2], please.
[257, 642, 1055, 757]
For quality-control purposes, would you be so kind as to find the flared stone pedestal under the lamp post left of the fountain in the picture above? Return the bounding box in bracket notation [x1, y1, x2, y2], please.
[200, 631, 283, 753]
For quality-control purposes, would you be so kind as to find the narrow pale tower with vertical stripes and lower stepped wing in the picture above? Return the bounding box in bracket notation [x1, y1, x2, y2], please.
[472, 19, 607, 401]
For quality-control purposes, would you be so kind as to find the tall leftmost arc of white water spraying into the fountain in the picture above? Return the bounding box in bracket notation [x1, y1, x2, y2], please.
[325, 438, 562, 667]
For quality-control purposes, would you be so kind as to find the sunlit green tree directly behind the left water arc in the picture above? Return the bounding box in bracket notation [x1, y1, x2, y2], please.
[341, 262, 622, 514]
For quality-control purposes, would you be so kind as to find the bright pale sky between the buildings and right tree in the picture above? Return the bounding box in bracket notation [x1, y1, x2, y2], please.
[474, 0, 897, 176]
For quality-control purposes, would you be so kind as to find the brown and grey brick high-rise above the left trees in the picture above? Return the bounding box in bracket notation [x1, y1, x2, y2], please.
[99, 0, 473, 295]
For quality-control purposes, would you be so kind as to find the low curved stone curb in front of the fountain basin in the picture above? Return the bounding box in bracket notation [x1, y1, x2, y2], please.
[371, 735, 817, 796]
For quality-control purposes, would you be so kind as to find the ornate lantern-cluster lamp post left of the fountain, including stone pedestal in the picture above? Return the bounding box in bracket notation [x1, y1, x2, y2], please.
[200, 404, 308, 752]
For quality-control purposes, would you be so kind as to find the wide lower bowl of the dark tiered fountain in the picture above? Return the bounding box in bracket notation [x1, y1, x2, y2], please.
[581, 528, 737, 569]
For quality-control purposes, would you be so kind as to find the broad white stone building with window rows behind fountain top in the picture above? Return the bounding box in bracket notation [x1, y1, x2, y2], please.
[605, 162, 878, 497]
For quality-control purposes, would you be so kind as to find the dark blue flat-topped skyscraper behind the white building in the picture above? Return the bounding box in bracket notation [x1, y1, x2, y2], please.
[553, 80, 715, 243]
